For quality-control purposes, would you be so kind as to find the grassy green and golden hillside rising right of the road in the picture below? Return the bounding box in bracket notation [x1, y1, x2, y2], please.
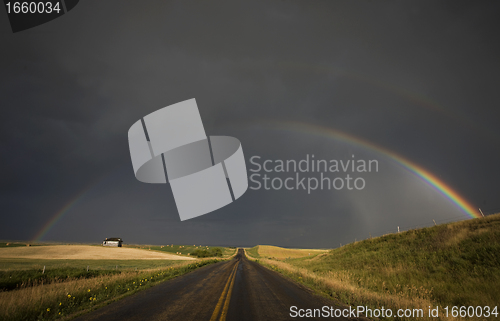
[247, 214, 500, 320]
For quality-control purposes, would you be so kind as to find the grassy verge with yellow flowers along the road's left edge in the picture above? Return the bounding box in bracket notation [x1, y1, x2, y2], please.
[0, 259, 220, 321]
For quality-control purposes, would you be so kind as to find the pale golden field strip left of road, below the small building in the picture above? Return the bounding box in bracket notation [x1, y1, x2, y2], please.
[0, 245, 194, 260]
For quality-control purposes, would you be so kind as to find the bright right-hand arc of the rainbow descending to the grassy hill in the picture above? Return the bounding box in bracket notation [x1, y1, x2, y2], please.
[258, 121, 481, 218]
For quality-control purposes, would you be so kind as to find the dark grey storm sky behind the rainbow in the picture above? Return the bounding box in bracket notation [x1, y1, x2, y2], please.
[0, 0, 500, 247]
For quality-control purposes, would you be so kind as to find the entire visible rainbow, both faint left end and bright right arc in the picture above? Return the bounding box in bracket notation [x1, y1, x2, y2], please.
[33, 120, 481, 242]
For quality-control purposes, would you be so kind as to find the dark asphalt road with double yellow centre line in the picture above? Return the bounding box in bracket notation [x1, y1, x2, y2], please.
[75, 249, 360, 321]
